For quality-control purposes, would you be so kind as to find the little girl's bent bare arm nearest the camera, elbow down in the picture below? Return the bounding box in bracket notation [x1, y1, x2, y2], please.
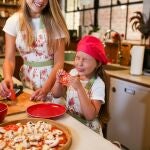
[70, 77, 101, 120]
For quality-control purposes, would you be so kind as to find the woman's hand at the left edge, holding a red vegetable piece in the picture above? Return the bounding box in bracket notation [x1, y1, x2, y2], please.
[0, 78, 13, 97]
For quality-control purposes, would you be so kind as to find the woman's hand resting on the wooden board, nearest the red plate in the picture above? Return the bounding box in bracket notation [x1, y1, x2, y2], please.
[30, 88, 47, 101]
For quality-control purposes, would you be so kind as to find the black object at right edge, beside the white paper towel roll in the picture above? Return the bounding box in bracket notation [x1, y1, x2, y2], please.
[143, 49, 150, 75]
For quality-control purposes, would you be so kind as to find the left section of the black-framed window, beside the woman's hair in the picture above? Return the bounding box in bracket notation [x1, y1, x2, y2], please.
[65, 0, 94, 30]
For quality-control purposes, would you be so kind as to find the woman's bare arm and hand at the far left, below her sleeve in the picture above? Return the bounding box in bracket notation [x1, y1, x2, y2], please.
[0, 33, 16, 96]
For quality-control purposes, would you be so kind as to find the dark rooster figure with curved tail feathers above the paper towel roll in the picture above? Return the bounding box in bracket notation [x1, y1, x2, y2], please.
[130, 11, 150, 45]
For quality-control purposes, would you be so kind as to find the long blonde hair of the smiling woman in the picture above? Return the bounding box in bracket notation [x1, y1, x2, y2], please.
[19, 0, 70, 50]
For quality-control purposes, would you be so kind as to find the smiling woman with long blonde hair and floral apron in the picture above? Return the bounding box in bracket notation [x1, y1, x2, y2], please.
[0, 0, 69, 100]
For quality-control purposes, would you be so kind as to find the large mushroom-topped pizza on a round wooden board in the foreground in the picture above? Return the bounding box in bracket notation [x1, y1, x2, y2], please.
[0, 119, 71, 150]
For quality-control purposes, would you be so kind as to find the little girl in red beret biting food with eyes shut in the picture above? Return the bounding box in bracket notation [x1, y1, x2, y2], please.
[52, 36, 108, 135]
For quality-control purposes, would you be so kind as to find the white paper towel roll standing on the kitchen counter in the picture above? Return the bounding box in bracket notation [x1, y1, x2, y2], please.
[130, 46, 145, 75]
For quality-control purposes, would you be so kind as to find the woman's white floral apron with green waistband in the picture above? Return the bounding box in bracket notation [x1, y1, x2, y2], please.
[16, 18, 54, 90]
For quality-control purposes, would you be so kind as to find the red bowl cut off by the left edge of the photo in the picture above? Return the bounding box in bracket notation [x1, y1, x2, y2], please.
[0, 103, 8, 122]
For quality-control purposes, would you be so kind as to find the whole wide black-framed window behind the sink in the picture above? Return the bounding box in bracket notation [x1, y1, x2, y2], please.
[65, 0, 143, 40]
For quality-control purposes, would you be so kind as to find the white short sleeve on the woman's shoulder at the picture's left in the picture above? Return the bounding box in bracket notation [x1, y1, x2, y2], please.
[3, 13, 19, 37]
